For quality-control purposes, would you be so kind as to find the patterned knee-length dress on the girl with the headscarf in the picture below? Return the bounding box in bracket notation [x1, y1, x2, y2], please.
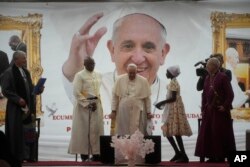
[162, 78, 192, 137]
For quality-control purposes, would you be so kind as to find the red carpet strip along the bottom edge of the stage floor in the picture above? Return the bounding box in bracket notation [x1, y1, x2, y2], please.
[23, 161, 229, 167]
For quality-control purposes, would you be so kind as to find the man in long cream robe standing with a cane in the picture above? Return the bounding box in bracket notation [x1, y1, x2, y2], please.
[69, 57, 104, 161]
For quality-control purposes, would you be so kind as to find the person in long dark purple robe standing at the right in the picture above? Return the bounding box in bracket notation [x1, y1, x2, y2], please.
[195, 58, 236, 162]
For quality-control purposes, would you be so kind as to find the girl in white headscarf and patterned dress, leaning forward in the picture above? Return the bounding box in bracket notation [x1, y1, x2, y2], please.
[156, 66, 192, 162]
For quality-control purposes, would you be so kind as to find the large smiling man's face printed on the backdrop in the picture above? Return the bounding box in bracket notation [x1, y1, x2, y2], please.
[108, 14, 169, 84]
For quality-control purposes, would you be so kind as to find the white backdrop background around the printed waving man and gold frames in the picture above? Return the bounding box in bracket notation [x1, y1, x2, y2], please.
[0, 1, 250, 160]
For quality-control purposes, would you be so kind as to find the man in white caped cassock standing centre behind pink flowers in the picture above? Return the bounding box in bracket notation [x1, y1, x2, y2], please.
[110, 64, 151, 135]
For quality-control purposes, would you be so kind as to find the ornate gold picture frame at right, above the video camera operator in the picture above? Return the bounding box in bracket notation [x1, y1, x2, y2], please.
[210, 11, 250, 121]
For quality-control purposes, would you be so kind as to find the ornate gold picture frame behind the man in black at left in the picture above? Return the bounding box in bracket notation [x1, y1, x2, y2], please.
[0, 13, 43, 122]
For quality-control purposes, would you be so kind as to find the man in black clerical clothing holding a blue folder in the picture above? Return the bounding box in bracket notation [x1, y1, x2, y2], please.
[2, 51, 43, 162]
